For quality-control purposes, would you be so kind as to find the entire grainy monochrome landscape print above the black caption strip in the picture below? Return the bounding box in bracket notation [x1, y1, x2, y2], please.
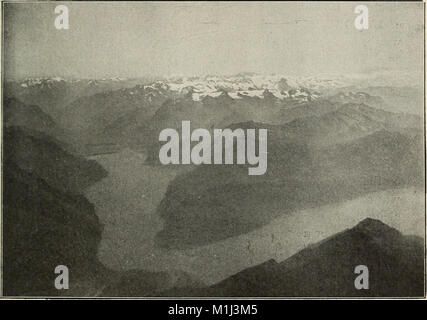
[2, 2, 425, 297]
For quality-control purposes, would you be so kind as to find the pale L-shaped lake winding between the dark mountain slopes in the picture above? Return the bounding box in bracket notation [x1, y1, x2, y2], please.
[86, 150, 424, 284]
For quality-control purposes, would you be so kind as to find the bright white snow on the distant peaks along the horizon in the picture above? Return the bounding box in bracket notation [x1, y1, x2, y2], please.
[12, 73, 354, 101]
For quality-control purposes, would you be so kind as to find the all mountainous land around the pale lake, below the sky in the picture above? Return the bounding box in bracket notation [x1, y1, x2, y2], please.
[3, 74, 424, 296]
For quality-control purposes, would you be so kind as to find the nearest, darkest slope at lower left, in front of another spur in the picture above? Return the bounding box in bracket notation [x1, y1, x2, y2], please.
[3, 160, 105, 296]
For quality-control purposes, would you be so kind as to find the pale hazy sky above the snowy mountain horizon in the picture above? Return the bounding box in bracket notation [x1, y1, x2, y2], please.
[3, 2, 424, 79]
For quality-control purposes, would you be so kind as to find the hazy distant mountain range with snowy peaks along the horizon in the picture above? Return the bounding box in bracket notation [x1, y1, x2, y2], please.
[5, 73, 422, 154]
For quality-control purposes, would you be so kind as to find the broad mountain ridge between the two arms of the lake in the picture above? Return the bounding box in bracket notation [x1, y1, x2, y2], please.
[157, 124, 424, 248]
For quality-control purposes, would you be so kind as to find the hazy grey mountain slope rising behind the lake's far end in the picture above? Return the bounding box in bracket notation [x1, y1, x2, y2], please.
[59, 84, 170, 153]
